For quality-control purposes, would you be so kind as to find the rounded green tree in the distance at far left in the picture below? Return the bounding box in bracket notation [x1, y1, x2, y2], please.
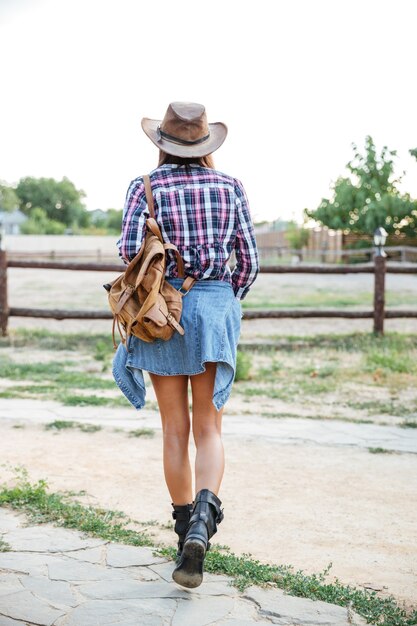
[16, 177, 90, 227]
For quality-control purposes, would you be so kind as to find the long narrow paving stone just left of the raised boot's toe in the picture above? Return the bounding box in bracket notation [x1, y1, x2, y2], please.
[77, 580, 190, 602]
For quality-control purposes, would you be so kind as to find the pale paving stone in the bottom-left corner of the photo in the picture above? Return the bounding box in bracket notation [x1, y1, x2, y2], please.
[0, 589, 65, 626]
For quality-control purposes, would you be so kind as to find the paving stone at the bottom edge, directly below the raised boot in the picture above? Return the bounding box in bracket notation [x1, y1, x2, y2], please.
[172, 596, 234, 626]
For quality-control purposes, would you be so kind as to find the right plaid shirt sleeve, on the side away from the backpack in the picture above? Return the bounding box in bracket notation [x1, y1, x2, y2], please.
[232, 180, 259, 300]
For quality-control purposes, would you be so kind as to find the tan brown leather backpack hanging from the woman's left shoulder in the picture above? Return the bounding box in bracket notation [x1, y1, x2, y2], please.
[104, 175, 195, 349]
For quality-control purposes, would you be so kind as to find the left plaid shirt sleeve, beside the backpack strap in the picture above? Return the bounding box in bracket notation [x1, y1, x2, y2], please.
[116, 178, 149, 264]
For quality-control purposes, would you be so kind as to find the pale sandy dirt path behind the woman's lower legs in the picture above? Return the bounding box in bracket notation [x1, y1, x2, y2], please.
[0, 409, 417, 606]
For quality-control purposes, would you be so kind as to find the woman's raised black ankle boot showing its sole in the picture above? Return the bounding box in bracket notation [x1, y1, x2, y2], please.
[172, 489, 224, 587]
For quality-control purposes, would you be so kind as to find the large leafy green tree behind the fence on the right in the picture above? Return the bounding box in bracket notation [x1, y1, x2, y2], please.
[305, 136, 417, 237]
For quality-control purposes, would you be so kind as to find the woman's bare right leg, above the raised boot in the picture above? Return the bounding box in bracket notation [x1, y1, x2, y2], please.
[190, 363, 224, 494]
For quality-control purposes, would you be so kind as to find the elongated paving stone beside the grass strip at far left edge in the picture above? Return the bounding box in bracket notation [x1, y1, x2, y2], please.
[7, 524, 105, 552]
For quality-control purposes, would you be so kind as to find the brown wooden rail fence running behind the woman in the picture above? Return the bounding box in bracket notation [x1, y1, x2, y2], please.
[0, 250, 417, 336]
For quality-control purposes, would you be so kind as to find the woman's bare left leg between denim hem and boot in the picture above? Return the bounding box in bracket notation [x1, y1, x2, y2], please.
[149, 374, 193, 505]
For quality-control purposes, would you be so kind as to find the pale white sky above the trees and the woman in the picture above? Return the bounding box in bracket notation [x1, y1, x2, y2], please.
[0, 0, 417, 221]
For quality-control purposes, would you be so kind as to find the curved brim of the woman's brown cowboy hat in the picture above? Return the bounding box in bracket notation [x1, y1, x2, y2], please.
[142, 117, 227, 158]
